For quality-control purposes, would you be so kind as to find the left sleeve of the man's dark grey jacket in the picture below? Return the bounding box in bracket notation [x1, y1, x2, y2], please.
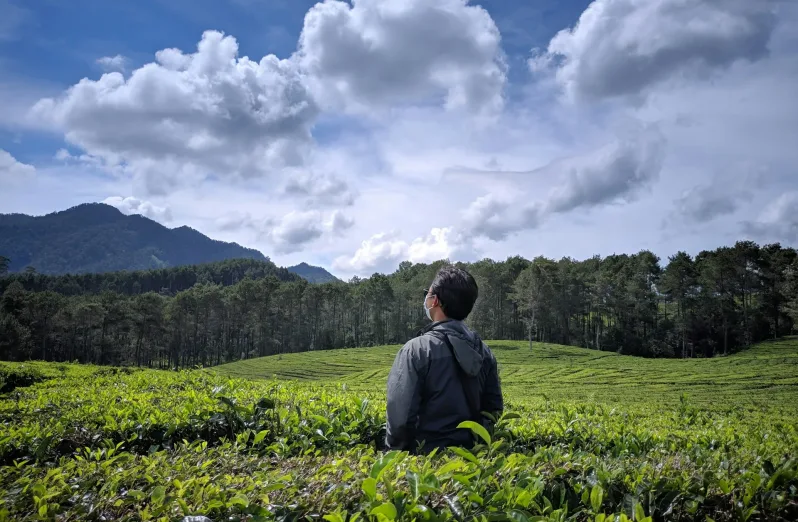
[385, 340, 429, 450]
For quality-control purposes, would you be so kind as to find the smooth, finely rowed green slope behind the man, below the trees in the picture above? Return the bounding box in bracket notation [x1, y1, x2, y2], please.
[212, 338, 798, 412]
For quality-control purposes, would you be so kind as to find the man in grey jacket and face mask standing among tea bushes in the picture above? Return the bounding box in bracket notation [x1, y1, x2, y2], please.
[385, 266, 504, 453]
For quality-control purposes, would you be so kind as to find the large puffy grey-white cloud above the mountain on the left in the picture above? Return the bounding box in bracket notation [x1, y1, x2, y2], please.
[31, 31, 318, 194]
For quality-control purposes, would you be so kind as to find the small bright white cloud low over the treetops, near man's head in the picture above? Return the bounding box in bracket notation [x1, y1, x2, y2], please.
[333, 227, 473, 275]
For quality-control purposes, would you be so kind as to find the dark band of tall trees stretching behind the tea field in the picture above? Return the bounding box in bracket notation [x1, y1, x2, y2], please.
[0, 241, 798, 368]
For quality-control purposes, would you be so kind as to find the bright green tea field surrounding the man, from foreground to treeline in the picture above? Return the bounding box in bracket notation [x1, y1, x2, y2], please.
[0, 339, 798, 522]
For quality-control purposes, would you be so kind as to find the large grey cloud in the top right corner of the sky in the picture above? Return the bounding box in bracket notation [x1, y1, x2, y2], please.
[529, 0, 777, 100]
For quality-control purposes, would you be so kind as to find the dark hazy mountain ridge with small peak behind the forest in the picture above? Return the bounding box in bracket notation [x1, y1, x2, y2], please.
[0, 203, 334, 282]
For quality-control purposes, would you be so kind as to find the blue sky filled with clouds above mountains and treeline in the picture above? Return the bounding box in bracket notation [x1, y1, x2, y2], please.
[0, 0, 798, 277]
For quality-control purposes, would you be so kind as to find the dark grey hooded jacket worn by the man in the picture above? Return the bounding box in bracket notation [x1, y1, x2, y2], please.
[385, 320, 504, 452]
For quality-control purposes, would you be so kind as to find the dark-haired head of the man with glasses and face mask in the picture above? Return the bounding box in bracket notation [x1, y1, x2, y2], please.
[424, 266, 479, 321]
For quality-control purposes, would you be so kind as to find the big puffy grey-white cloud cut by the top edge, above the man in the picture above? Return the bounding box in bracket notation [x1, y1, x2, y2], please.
[297, 0, 506, 114]
